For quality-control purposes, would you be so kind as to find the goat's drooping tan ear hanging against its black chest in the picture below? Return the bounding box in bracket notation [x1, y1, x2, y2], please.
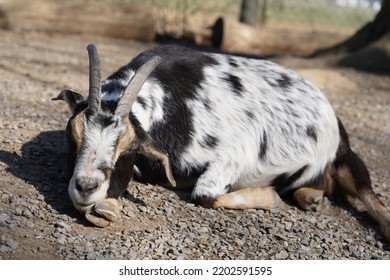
[139, 138, 176, 187]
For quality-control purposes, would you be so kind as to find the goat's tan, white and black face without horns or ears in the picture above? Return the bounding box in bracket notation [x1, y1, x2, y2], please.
[67, 110, 140, 211]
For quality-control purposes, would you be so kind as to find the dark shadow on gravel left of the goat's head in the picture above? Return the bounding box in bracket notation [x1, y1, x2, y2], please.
[0, 130, 82, 220]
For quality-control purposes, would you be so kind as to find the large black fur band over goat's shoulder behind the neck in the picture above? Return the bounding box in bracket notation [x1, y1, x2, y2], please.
[125, 46, 218, 165]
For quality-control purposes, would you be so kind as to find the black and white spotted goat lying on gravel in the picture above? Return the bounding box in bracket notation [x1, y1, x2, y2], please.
[54, 44, 390, 239]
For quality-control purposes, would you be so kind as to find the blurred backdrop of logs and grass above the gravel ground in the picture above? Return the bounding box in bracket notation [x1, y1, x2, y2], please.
[0, 0, 390, 59]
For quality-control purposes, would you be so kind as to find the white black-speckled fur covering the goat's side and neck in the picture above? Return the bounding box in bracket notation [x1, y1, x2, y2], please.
[133, 55, 339, 197]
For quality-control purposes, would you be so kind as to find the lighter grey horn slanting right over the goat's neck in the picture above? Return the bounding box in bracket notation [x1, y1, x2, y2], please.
[115, 56, 162, 116]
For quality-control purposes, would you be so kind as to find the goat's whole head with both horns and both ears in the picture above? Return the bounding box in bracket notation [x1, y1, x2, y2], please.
[53, 44, 175, 212]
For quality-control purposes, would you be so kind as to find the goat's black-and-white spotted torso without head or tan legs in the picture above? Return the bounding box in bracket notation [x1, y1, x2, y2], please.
[102, 47, 339, 202]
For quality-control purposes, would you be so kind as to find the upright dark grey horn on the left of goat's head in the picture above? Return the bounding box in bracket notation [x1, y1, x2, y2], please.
[87, 44, 101, 114]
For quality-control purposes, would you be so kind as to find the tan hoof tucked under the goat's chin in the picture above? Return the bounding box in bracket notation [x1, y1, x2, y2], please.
[85, 198, 121, 228]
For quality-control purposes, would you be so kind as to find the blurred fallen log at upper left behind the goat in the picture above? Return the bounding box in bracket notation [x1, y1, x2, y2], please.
[5, 0, 156, 41]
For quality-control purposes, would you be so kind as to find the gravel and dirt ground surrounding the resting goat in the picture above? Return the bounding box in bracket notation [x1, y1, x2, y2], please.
[0, 31, 390, 259]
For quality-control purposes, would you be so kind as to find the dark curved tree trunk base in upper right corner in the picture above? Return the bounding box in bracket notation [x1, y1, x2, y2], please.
[311, 0, 390, 57]
